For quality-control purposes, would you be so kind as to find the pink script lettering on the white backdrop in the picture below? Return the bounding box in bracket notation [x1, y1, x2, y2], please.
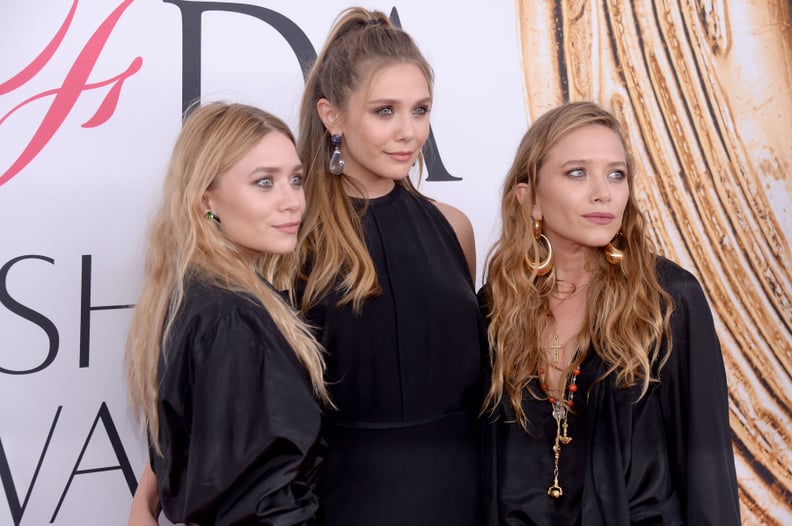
[0, 0, 143, 186]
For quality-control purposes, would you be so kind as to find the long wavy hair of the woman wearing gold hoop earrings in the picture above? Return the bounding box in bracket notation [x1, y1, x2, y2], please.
[485, 102, 672, 429]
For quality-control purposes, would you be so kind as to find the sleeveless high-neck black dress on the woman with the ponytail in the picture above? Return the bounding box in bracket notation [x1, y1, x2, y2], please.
[300, 185, 486, 526]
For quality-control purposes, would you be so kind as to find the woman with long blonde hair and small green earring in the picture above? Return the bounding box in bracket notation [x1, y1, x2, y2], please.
[126, 102, 329, 525]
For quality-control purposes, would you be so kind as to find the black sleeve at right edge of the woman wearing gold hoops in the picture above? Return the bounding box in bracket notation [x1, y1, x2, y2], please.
[659, 260, 740, 526]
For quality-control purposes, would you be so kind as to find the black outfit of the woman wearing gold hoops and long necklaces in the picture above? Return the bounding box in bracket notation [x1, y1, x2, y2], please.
[498, 258, 740, 526]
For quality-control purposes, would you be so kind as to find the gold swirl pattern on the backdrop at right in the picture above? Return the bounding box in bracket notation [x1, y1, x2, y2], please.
[517, 0, 792, 524]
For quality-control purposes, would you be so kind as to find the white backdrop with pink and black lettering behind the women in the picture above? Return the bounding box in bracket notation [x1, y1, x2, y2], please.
[0, 0, 527, 526]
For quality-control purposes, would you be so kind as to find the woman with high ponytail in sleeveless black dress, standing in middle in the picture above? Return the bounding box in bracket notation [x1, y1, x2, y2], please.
[295, 8, 489, 526]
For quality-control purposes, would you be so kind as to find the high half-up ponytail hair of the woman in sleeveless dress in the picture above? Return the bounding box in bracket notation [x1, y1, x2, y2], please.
[297, 7, 433, 312]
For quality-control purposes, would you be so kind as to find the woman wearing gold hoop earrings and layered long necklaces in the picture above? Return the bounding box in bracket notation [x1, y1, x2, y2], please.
[479, 102, 740, 526]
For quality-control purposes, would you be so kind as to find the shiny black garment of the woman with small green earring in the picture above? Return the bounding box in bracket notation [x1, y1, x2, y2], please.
[150, 281, 324, 526]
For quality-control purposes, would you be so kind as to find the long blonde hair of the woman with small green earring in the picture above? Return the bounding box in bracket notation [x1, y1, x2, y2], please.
[126, 102, 329, 452]
